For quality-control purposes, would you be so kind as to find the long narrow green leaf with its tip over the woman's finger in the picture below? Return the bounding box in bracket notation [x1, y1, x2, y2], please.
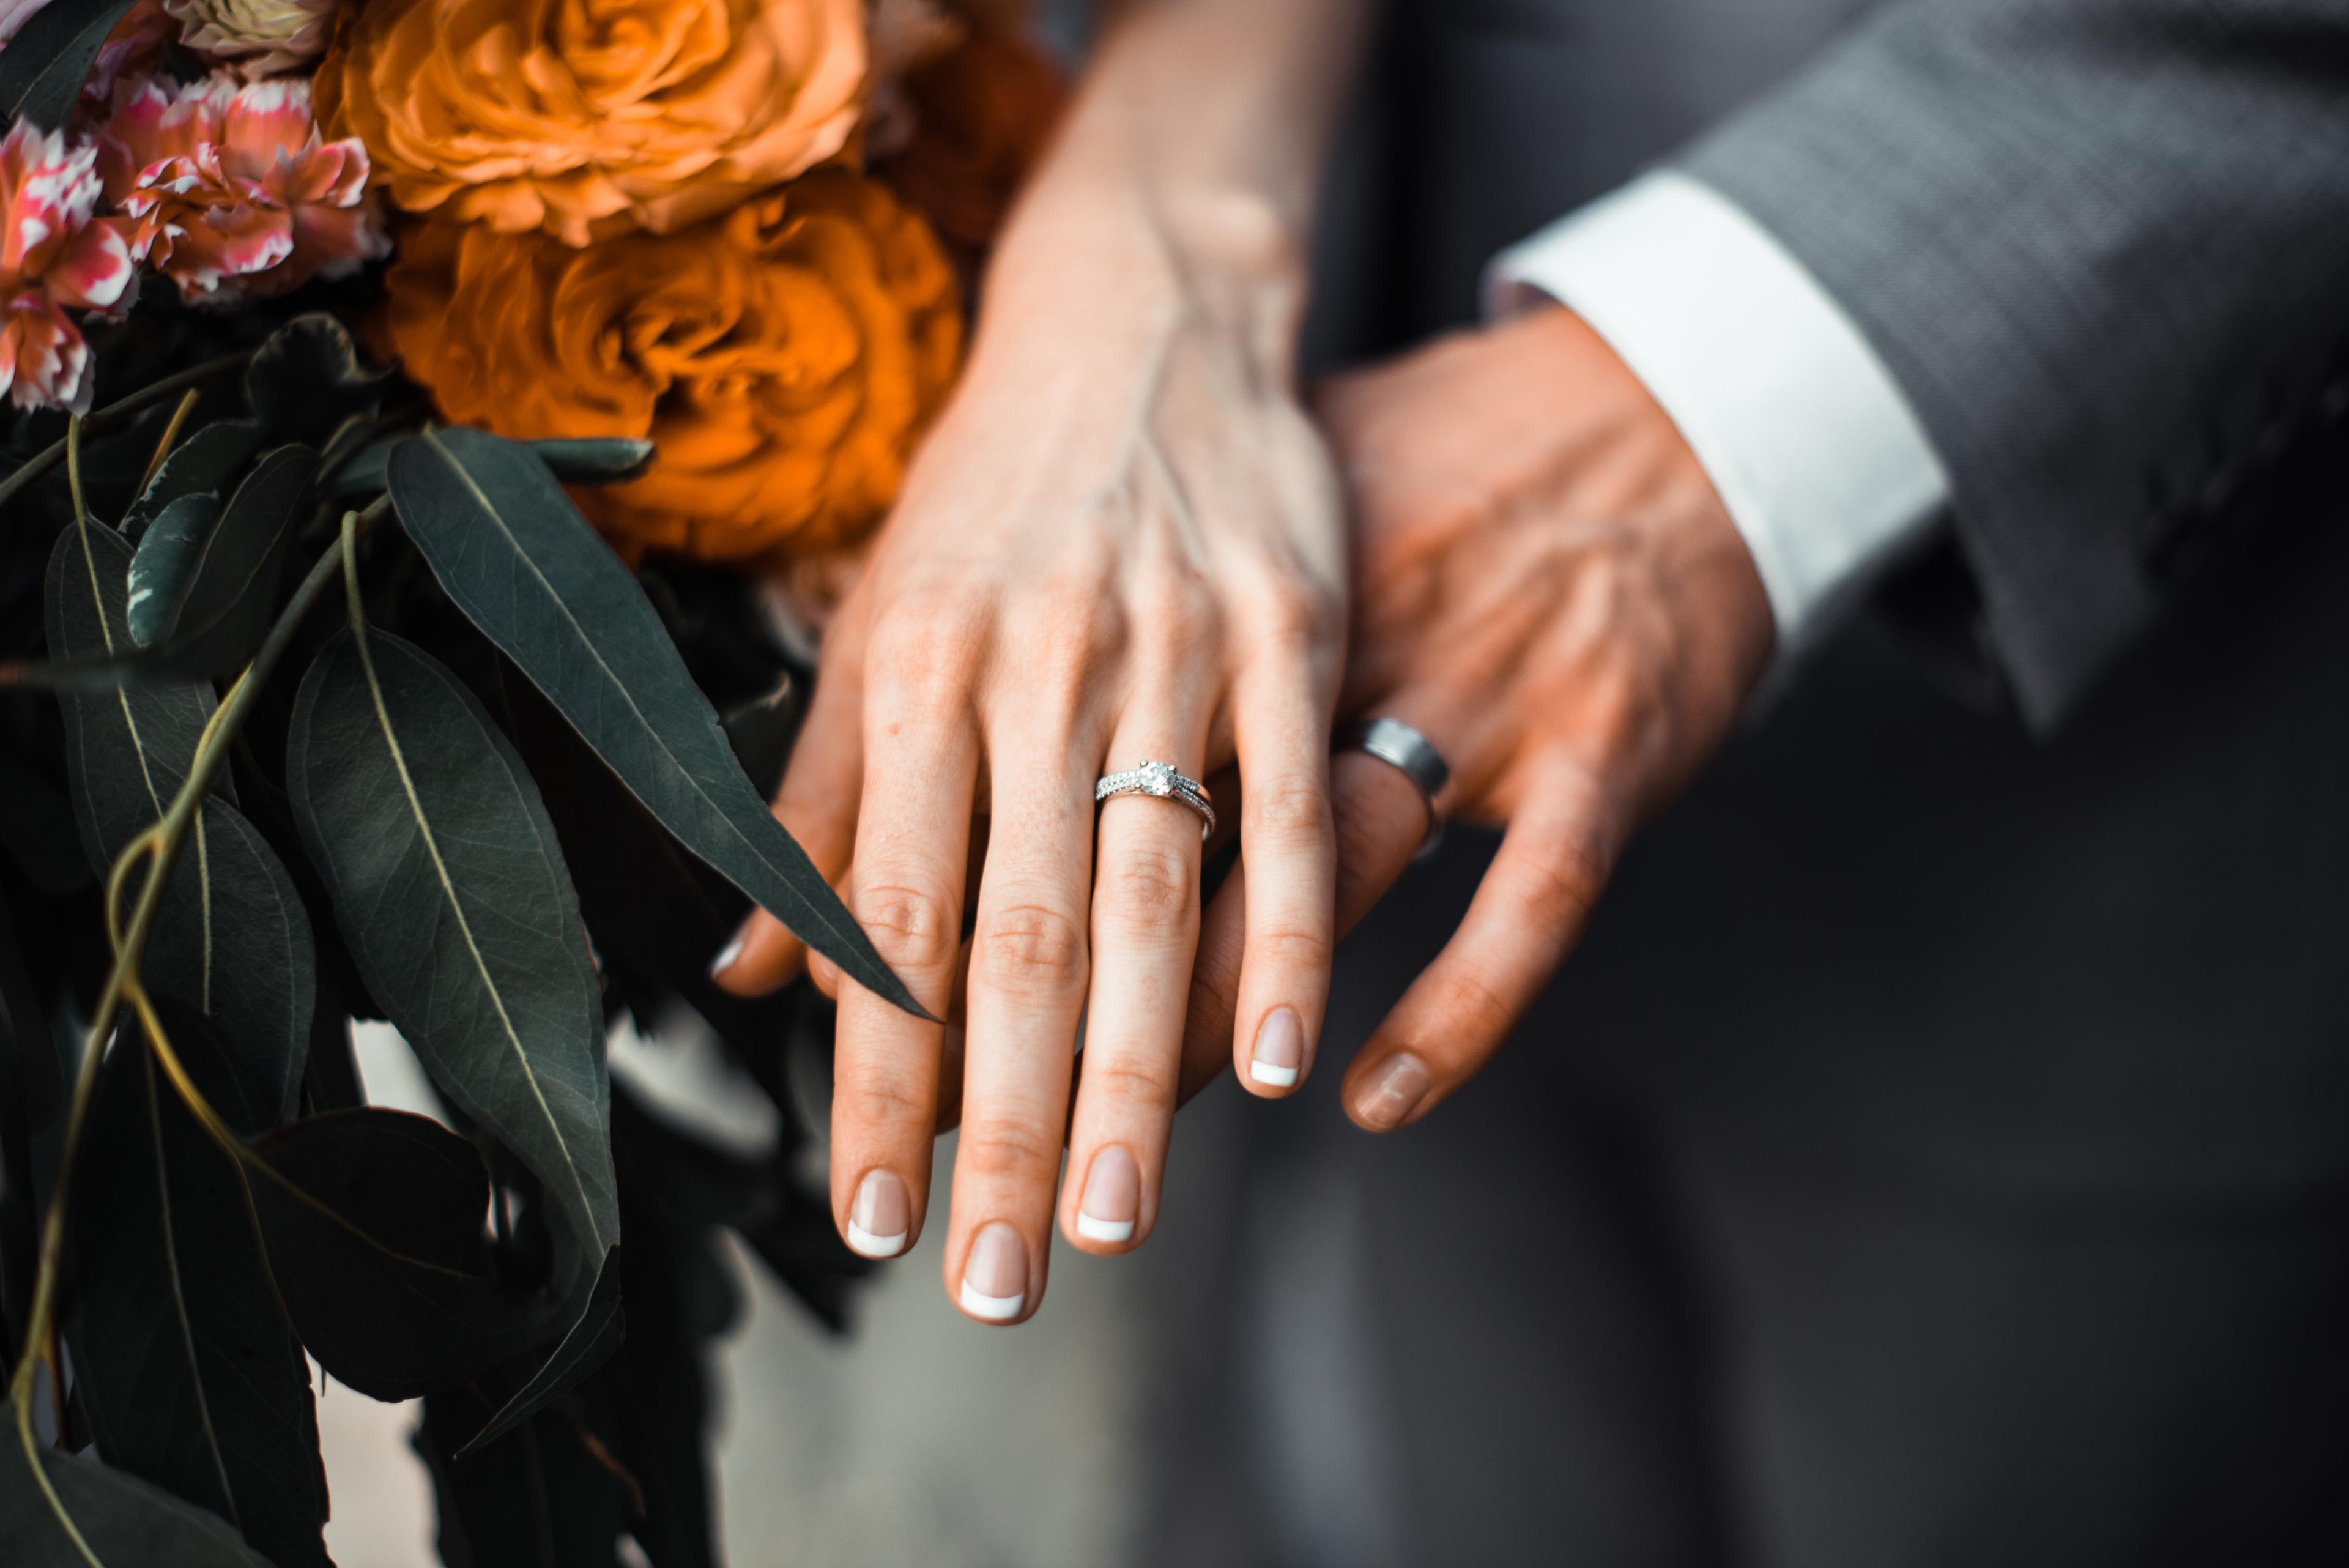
[390, 430, 923, 1013]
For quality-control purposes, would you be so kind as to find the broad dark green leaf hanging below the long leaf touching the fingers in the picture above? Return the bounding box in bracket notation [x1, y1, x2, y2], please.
[286, 630, 620, 1291]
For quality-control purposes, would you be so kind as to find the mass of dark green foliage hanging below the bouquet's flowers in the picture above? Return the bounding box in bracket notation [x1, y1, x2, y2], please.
[0, 300, 902, 1568]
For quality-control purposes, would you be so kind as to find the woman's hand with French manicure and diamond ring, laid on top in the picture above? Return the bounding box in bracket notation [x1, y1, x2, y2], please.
[719, 0, 1371, 1321]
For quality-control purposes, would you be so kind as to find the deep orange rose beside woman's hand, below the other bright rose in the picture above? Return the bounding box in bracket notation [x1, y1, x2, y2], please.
[385, 169, 963, 560]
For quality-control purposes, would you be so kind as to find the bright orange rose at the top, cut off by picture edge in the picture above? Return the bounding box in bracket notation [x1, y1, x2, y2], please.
[317, 0, 864, 245]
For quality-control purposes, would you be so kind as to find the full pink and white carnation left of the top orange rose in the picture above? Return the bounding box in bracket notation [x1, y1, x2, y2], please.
[98, 70, 392, 306]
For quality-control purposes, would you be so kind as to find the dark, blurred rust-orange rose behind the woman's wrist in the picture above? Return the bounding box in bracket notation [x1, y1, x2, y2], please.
[874, 28, 1069, 261]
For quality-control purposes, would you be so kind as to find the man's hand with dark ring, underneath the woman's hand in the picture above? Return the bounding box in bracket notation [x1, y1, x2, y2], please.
[1184, 308, 1773, 1131]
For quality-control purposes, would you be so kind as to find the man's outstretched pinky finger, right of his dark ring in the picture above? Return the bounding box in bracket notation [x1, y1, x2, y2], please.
[1343, 764, 1623, 1133]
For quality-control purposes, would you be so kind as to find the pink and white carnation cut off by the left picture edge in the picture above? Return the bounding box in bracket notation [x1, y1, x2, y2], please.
[0, 120, 139, 414]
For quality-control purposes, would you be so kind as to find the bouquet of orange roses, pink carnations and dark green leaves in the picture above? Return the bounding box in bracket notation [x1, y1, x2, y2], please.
[0, 0, 1057, 1568]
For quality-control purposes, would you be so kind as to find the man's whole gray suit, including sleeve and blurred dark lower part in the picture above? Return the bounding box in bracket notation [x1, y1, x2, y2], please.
[1252, 0, 2349, 1568]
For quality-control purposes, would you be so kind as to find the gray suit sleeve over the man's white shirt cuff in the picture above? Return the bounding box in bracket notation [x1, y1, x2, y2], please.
[1680, 0, 2349, 729]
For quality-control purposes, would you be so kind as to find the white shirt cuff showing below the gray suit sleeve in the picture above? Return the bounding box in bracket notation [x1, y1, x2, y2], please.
[1487, 169, 1950, 649]
